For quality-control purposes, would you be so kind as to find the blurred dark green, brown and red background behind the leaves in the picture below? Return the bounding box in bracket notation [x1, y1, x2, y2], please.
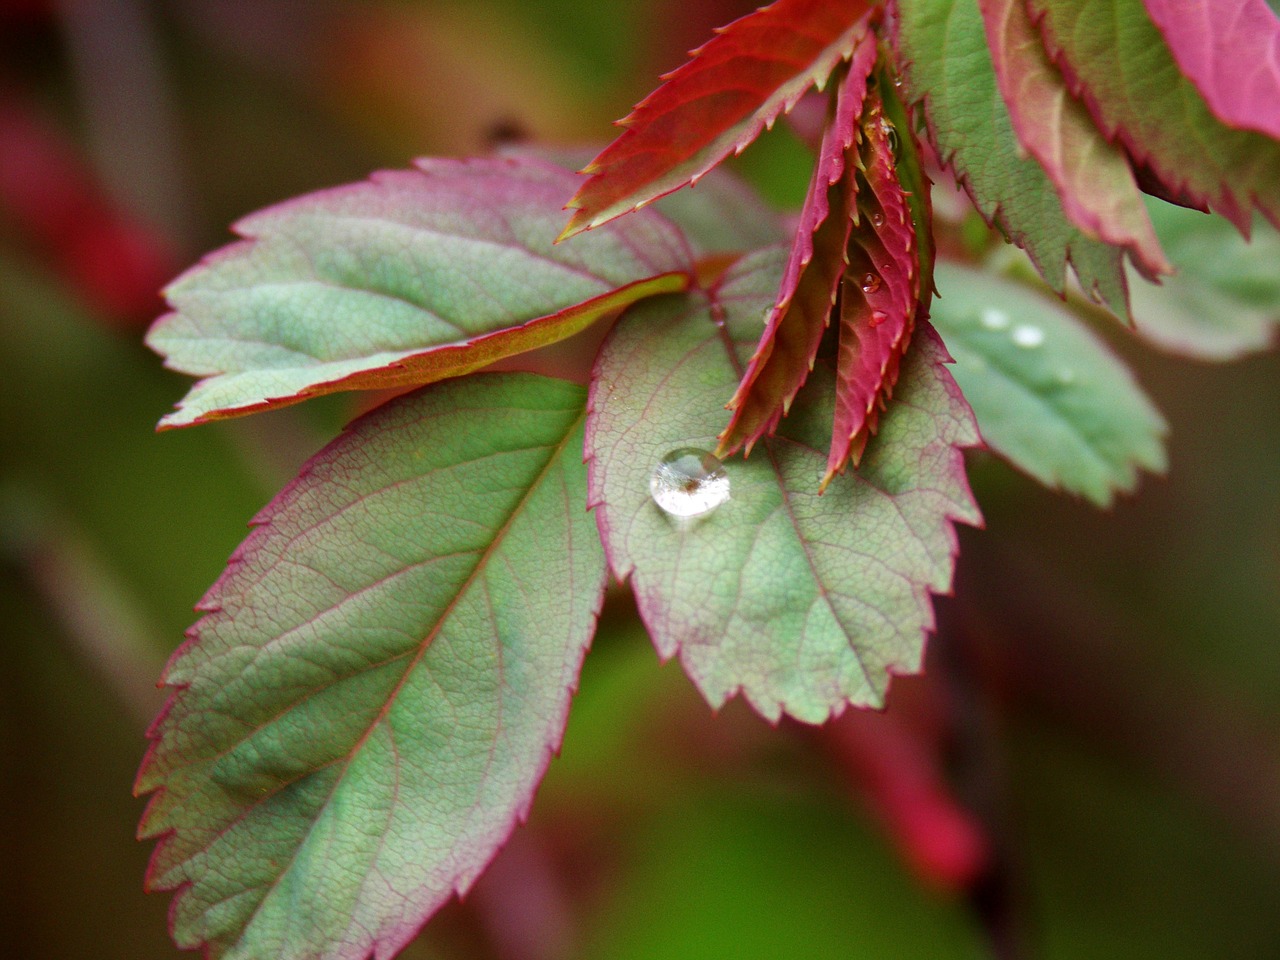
[0, 0, 1280, 960]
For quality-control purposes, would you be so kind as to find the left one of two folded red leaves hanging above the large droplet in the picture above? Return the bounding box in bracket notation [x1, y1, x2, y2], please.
[719, 35, 876, 456]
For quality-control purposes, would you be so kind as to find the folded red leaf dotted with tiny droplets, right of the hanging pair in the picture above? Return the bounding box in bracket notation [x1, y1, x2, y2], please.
[823, 92, 920, 486]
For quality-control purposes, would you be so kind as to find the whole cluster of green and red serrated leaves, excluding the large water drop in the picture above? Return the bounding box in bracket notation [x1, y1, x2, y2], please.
[138, 0, 1280, 960]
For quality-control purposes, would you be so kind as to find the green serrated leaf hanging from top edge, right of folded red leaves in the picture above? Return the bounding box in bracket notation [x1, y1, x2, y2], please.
[895, 0, 1126, 316]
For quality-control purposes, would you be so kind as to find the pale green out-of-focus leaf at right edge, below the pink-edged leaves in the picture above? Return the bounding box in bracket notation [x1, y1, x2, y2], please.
[1129, 198, 1280, 360]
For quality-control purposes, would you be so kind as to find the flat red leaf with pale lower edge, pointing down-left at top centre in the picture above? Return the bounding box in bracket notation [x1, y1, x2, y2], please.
[561, 0, 878, 238]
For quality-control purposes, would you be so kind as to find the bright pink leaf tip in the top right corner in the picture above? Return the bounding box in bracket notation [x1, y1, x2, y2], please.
[1143, 0, 1280, 140]
